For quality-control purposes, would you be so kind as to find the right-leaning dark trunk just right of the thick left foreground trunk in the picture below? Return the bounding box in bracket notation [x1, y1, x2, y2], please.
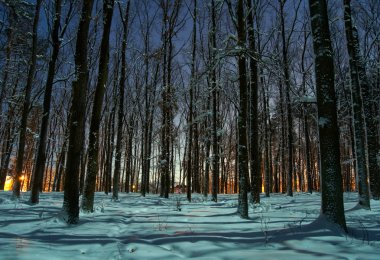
[82, 0, 114, 212]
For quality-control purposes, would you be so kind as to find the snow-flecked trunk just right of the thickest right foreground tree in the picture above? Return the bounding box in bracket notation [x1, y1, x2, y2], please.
[343, 0, 371, 209]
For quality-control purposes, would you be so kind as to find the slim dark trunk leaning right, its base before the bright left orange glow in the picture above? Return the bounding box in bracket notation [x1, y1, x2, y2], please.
[13, 0, 42, 198]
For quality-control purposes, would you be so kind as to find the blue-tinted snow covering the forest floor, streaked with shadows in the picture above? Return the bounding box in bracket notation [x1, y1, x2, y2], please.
[0, 191, 380, 260]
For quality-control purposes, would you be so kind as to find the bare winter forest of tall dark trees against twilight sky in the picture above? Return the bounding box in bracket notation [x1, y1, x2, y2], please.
[0, 0, 380, 231]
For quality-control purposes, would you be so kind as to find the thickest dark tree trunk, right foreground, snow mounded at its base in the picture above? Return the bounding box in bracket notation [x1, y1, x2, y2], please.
[309, 0, 347, 232]
